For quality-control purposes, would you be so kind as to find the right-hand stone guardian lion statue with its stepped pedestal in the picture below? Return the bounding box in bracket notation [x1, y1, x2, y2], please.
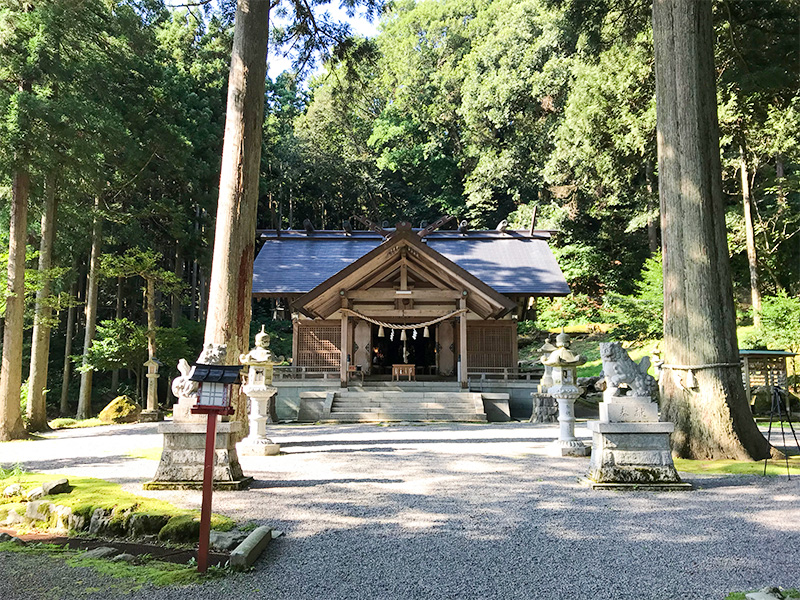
[587, 342, 691, 489]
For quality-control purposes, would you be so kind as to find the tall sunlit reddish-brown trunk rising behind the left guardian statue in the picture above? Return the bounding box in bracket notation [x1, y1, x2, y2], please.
[205, 0, 270, 432]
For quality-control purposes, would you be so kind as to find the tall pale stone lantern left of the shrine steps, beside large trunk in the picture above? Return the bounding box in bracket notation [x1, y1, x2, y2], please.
[239, 325, 281, 456]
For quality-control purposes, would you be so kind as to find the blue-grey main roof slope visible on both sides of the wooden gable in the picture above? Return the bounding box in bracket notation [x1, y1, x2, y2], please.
[253, 231, 569, 297]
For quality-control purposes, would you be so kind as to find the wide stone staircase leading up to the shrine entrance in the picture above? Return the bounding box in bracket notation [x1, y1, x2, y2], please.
[326, 381, 486, 423]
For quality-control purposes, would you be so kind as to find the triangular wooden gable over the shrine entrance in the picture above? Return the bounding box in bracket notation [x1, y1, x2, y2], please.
[294, 223, 516, 321]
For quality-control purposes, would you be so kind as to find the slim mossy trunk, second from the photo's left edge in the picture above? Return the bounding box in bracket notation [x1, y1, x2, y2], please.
[27, 171, 57, 431]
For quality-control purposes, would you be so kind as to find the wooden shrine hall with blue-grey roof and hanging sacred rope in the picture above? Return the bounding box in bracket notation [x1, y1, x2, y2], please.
[253, 218, 569, 388]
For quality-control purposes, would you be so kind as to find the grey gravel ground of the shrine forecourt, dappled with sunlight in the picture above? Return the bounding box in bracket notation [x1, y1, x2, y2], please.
[0, 423, 800, 600]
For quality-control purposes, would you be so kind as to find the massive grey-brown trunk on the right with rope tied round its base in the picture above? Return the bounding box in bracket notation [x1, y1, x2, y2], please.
[653, 0, 770, 459]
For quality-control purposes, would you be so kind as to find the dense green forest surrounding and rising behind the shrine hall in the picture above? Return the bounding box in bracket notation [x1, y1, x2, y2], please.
[0, 0, 800, 429]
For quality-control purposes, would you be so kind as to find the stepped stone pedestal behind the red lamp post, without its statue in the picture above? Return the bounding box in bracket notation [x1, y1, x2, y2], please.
[144, 415, 253, 490]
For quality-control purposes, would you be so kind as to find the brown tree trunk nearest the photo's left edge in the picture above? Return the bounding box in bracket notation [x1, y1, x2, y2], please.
[0, 169, 31, 442]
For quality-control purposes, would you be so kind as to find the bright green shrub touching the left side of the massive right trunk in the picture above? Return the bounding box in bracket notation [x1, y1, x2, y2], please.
[603, 254, 664, 341]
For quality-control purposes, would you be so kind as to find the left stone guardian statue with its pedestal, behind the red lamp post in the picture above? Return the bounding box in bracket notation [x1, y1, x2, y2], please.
[144, 344, 253, 490]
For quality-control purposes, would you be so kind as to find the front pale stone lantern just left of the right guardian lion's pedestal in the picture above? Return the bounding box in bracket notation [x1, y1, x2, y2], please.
[542, 330, 590, 456]
